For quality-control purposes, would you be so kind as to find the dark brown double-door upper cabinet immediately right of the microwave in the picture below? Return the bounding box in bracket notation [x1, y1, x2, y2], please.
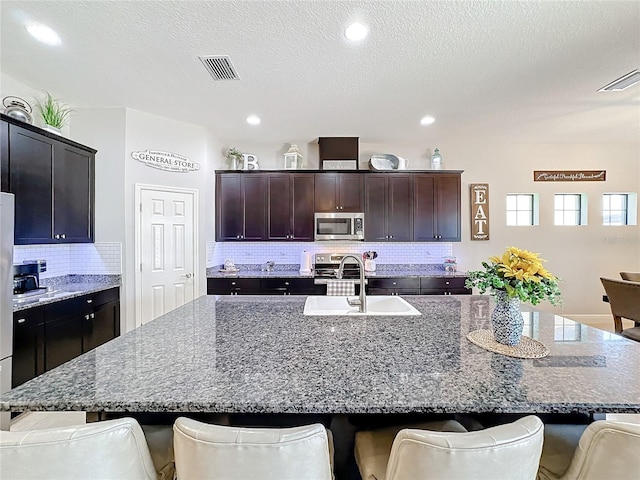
[364, 173, 413, 242]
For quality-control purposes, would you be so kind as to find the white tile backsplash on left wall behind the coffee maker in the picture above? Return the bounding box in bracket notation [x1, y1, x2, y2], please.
[13, 242, 122, 279]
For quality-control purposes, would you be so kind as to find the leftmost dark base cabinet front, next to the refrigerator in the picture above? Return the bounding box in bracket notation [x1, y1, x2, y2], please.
[11, 307, 44, 388]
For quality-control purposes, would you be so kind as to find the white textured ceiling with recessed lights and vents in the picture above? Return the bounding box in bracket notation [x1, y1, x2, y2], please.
[0, 0, 640, 145]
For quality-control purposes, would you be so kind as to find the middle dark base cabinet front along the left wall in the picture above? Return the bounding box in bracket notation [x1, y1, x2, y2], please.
[45, 299, 82, 371]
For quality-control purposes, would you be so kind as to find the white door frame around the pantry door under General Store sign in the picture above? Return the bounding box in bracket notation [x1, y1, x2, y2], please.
[134, 183, 200, 328]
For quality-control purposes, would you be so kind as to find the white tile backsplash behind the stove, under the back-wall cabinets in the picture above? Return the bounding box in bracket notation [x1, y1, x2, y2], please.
[207, 242, 453, 268]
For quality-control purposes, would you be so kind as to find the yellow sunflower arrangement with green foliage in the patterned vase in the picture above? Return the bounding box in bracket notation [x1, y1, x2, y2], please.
[465, 247, 562, 305]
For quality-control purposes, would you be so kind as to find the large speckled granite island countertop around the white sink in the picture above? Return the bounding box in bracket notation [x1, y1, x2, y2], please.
[0, 295, 640, 414]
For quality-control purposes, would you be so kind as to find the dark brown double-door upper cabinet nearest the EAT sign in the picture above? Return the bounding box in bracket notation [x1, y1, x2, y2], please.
[413, 173, 461, 242]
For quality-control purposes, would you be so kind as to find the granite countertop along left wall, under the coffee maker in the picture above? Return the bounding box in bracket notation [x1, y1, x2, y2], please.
[13, 275, 121, 312]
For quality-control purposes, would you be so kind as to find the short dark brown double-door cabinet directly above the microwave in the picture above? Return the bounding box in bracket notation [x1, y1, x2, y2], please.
[315, 173, 364, 212]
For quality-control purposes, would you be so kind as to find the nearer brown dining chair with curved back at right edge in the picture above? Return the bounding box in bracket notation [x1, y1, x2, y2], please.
[600, 277, 640, 342]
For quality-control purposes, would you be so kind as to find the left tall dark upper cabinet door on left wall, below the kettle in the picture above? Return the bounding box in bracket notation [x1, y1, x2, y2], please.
[9, 125, 54, 245]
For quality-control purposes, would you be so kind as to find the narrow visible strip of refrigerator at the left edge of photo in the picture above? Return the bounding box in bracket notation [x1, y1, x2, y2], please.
[0, 193, 14, 430]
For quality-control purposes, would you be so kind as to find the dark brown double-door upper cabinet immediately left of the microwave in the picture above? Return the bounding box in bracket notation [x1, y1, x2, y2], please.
[266, 173, 314, 242]
